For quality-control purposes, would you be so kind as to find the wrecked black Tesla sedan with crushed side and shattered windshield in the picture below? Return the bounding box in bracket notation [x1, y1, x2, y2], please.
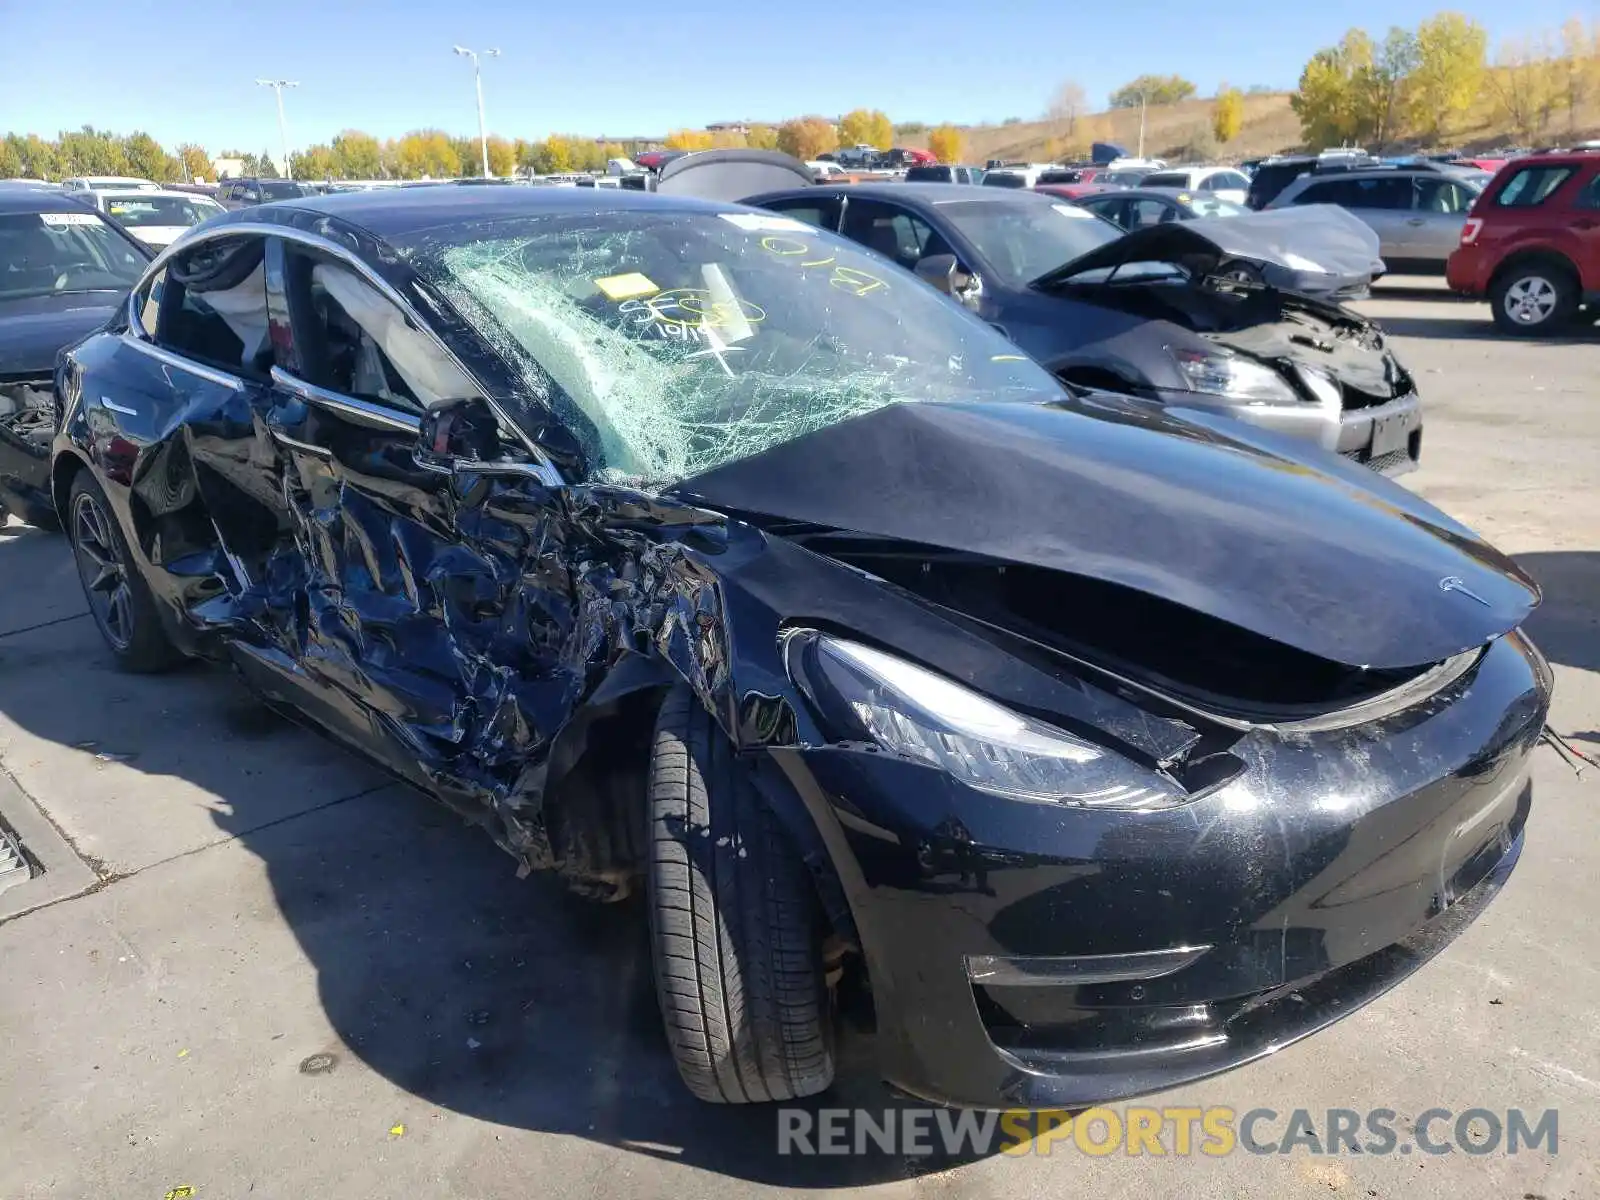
[50, 186, 1550, 1107]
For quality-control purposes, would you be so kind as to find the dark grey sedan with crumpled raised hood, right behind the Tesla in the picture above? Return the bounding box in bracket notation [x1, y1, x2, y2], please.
[748, 180, 1422, 475]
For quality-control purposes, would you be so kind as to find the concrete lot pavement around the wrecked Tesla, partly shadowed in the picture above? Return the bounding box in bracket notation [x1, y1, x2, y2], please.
[0, 285, 1600, 1200]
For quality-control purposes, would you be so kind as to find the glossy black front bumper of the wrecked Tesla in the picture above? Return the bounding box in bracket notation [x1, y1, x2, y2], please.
[774, 634, 1549, 1109]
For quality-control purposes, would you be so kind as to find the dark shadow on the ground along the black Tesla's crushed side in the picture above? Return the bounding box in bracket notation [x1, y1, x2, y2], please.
[0, 526, 998, 1189]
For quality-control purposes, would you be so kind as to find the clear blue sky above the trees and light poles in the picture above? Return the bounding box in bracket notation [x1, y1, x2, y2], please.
[0, 0, 1600, 152]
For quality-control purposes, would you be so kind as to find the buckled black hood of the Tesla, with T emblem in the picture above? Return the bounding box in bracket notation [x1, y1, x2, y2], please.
[677, 394, 1539, 670]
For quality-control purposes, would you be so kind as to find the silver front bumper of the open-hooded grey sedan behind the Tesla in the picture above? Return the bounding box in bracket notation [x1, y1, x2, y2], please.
[1160, 392, 1422, 475]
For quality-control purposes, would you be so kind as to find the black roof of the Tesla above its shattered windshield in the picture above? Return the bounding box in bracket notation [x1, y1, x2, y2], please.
[200, 184, 761, 238]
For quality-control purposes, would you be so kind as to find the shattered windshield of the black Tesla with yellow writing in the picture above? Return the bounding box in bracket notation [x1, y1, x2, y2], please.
[414, 208, 1059, 486]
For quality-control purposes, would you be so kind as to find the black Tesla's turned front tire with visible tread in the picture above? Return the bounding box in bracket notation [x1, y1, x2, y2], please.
[648, 688, 834, 1104]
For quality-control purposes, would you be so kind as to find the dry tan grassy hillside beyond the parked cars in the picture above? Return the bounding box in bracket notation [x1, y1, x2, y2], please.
[934, 91, 1600, 163]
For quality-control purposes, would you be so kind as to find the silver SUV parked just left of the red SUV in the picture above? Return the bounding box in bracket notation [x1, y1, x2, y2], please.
[1267, 168, 1490, 275]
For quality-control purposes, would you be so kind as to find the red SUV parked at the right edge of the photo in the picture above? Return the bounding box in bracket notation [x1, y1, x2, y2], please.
[1445, 150, 1600, 333]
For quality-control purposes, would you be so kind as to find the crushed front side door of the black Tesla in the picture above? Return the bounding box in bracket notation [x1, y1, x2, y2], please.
[262, 237, 582, 854]
